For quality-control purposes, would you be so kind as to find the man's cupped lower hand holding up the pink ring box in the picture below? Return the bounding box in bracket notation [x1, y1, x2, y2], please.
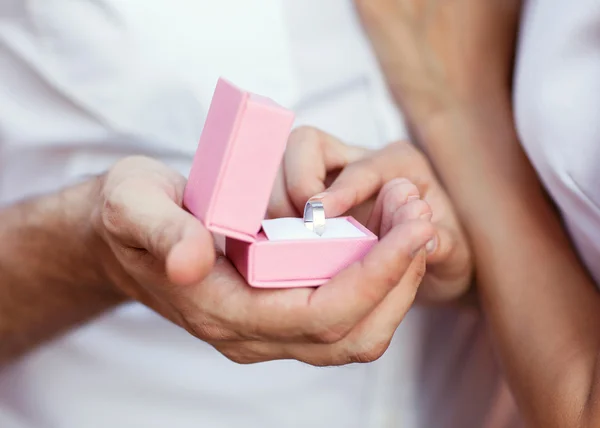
[92, 157, 434, 366]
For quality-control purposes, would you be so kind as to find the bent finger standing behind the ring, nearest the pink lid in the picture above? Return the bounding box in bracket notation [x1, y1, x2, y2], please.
[284, 127, 367, 212]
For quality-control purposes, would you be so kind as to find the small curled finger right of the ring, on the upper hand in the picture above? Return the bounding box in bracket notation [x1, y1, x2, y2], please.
[367, 178, 419, 236]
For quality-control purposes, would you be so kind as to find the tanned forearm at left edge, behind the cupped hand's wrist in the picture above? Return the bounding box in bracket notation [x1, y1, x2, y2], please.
[0, 180, 121, 367]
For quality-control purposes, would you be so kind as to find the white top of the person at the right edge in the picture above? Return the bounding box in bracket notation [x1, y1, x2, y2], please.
[515, 0, 600, 284]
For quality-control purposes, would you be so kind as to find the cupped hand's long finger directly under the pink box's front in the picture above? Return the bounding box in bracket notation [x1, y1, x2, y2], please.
[199, 220, 433, 342]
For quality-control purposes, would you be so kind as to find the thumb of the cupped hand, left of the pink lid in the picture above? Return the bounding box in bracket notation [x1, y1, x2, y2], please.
[101, 158, 214, 283]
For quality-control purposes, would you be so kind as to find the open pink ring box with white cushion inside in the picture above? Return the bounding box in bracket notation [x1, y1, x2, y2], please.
[184, 79, 377, 288]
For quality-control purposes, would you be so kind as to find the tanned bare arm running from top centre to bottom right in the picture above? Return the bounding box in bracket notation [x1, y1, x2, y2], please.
[355, 0, 600, 428]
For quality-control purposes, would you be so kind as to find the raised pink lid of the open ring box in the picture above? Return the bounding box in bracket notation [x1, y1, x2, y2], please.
[183, 78, 294, 242]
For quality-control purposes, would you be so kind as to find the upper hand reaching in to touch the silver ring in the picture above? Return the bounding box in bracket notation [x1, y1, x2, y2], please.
[268, 127, 473, 302]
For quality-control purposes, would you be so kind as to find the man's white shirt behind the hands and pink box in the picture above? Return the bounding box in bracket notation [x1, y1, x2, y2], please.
[0, 0, 504, 428]
